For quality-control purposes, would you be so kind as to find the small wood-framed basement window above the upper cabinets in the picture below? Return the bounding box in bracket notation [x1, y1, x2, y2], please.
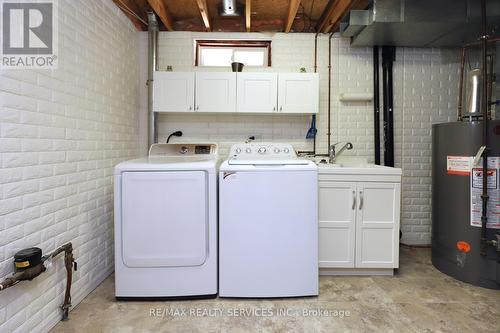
[195, 40, 271, 67]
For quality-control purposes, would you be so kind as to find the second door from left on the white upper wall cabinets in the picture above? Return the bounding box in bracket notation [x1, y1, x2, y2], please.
[195, 72, 236, 112]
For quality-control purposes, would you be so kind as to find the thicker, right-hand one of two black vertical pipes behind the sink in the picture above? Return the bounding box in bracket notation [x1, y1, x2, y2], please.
[382, 46, 396, 167]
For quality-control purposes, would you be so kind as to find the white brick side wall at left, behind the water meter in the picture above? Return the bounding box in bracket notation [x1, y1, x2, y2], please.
[0, 0, 139, 332]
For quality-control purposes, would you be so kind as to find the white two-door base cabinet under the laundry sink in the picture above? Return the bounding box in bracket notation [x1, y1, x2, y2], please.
[318, 171, 401, 275]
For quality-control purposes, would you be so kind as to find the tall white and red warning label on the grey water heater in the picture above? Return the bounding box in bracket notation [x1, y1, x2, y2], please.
[470, 157, 500, 229]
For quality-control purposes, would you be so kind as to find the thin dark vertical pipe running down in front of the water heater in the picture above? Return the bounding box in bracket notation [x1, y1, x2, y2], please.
[480, 0, 489, 256]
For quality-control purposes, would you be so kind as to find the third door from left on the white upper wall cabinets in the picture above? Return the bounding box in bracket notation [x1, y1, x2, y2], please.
[236, 73, 278, 112]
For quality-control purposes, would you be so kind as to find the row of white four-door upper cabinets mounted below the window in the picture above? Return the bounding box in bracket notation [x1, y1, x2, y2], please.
[153, 71, 319, 113]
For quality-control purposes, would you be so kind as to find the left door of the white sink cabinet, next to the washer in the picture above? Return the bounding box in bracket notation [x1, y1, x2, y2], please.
[318, 181, 356, 268]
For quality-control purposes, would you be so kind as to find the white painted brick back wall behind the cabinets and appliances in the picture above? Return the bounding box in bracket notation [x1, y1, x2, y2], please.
[149, 32, 458, 244]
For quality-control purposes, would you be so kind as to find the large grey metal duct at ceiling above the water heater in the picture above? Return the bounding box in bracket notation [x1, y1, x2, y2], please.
[340, 0, 500, 47]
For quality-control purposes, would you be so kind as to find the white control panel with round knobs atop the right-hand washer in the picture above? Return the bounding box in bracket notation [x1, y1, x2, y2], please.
[229, 142, 297, 160]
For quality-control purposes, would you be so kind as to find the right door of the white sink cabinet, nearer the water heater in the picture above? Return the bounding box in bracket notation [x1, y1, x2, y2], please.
[356, 183, 401, 268]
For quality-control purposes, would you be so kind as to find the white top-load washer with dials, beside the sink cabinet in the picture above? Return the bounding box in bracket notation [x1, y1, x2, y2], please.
[219, 143, 318, 297]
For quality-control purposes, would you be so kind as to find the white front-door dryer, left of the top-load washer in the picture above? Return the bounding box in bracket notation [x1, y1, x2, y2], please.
[114, 144, 217, 298]
